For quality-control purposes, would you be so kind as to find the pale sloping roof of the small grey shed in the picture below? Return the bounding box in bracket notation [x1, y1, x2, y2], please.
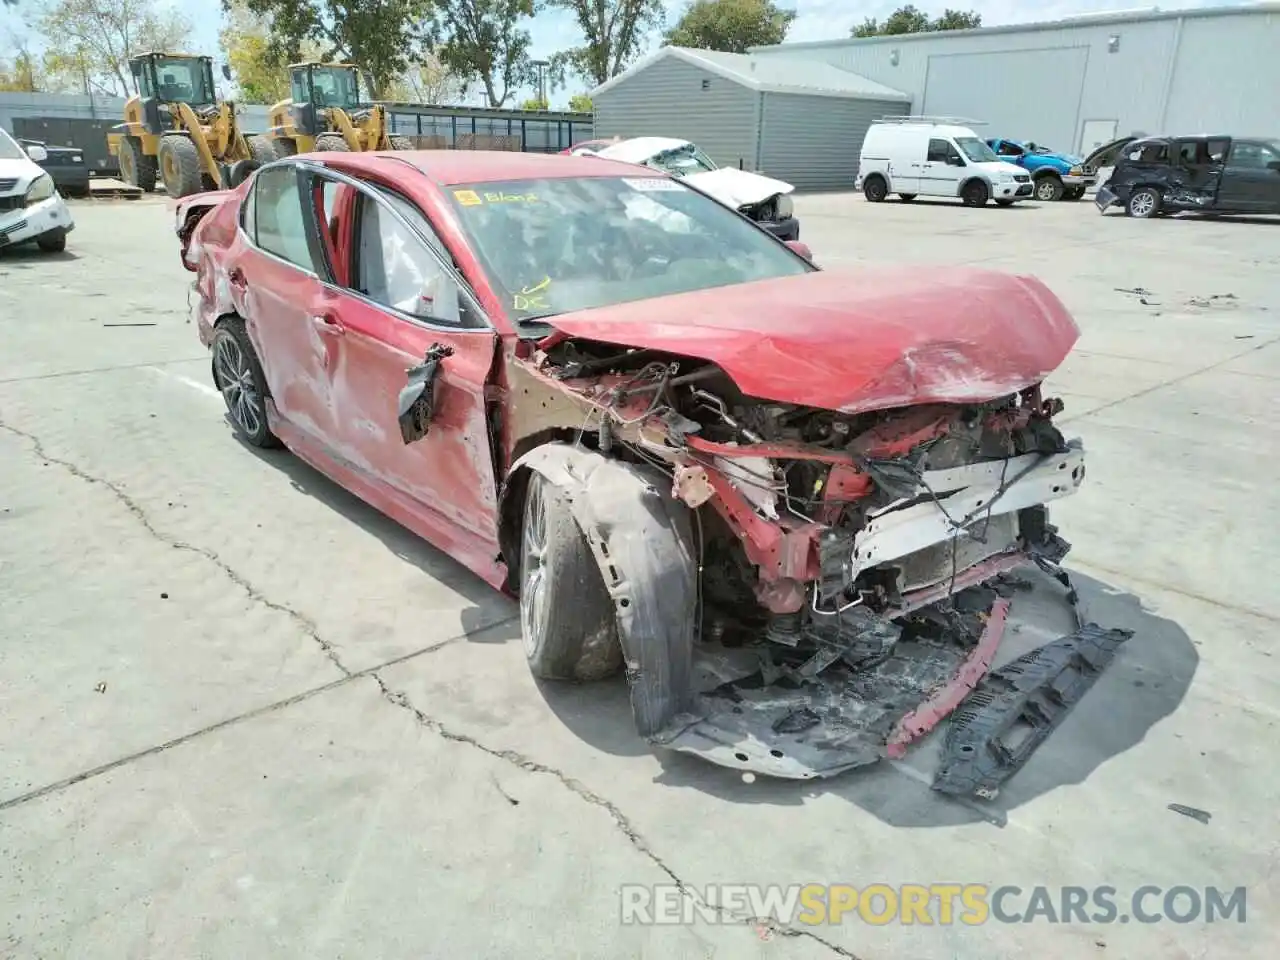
[591, 46, 911, 102]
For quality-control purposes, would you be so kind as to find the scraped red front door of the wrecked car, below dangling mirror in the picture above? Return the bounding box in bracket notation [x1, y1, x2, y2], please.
[302, 163, 498, 555]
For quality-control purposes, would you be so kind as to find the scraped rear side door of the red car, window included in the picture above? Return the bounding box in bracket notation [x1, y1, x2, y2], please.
[234, 164, 335, 439]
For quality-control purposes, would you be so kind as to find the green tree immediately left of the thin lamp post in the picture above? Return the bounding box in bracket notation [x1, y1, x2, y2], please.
[436, 0, 536, 108]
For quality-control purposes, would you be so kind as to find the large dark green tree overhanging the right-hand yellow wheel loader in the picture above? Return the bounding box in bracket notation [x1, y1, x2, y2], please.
[235, 0, 433, 97]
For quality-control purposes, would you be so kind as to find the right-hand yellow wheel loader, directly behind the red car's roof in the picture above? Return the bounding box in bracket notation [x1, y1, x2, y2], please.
[265, 63, 413, 156]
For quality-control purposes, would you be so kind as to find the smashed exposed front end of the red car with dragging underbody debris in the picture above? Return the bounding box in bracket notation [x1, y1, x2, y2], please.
[507, 333, 1128, 796]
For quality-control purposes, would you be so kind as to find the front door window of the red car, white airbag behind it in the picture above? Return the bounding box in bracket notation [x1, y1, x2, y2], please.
[356, 193, 462, 324]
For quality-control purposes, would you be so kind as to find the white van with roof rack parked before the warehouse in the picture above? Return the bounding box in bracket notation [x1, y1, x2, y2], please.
[854, 116, 1032, 206]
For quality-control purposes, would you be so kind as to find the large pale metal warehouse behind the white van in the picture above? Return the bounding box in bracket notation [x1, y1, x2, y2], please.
[747, 3, 1280, 161]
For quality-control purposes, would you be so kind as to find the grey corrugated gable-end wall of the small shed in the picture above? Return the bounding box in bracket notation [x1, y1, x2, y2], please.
[594, 58, 760, 170]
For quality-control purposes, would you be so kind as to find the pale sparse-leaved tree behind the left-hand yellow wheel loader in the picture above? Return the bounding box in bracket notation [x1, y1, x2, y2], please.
[35, 0, 191, 96]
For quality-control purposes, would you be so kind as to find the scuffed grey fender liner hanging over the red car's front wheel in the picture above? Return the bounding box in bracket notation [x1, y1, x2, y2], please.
[503, 443, 698, 737]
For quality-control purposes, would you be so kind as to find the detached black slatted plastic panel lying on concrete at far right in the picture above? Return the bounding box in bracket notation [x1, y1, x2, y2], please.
[933, 623, 1133, 800]
